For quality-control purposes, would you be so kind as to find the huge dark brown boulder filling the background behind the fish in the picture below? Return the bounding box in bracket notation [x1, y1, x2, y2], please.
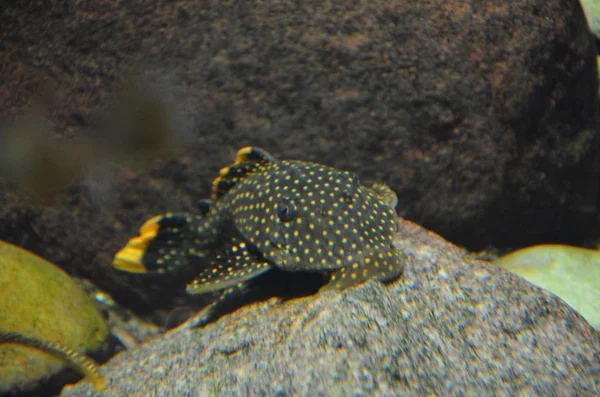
[0, 0, 598, 305]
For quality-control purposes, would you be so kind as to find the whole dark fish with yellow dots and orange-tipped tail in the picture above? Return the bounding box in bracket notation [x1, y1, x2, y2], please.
[113, 147, 404, 294]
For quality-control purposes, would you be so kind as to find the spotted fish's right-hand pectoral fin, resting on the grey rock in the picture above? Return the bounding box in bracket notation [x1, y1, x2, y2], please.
[322, 247, 406, 291]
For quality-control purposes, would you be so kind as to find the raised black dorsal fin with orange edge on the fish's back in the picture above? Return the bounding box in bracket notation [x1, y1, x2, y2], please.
[212, 146, 277, 201]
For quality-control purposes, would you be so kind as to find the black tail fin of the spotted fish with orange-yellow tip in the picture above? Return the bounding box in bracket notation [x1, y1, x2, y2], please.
[112, 213, 205, 273]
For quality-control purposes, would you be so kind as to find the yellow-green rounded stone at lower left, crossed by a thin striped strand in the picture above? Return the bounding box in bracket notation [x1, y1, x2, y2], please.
[0, 241, 108, 393]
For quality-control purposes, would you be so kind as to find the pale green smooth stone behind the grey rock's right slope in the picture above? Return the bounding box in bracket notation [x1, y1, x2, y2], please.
[495, 244, 600, 328]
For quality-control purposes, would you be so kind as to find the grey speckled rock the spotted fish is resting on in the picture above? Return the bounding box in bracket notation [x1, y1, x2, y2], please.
[57, 223, 600, 397]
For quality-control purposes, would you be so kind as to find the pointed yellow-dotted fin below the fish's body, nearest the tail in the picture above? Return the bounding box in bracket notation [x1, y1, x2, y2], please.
[186, 239, 271, 294]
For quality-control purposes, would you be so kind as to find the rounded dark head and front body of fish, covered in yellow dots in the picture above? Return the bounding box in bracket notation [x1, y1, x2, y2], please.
[228, 161, 396, 270]
